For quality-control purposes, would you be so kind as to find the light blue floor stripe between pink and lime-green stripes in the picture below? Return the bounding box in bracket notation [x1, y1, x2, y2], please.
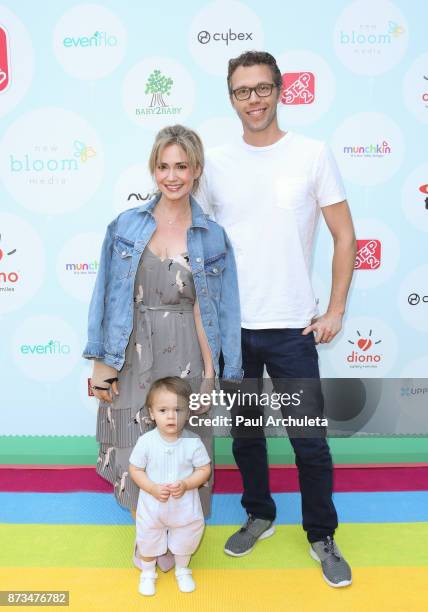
[0, 491, 428, 525]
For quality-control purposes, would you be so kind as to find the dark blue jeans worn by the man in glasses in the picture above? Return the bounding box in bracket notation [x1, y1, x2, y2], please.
[232, 329, 337, 542]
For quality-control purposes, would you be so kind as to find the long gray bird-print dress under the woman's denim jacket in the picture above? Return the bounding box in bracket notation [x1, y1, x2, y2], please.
[97, 247, 212, 516]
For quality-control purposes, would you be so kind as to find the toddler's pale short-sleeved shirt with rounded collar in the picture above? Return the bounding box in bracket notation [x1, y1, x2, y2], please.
[129, 427, 210, 484]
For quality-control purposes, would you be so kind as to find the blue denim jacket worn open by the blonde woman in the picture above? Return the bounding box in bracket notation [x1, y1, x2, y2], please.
[83, 194, 243, 382]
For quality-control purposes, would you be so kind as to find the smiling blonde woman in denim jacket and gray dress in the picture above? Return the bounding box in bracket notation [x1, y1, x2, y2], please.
[83, 125, 243, 568]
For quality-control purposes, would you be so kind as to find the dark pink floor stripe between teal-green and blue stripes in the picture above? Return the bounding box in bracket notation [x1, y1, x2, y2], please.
[0, 465, 428, 493]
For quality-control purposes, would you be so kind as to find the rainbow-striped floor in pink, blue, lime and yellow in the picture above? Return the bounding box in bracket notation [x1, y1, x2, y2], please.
[0, 464, 428, 612]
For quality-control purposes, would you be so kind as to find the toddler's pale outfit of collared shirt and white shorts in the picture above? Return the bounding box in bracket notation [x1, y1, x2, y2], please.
[129, 428, 210, 557]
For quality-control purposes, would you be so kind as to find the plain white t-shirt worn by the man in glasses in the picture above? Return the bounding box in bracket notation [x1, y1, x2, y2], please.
[196, 132, 346, 329]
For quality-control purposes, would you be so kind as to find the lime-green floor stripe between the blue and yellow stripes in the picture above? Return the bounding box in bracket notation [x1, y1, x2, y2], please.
[0, 523, 428, 569]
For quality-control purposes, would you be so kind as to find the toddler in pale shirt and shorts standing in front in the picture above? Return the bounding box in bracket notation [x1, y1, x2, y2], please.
[129, 376, 211, 595]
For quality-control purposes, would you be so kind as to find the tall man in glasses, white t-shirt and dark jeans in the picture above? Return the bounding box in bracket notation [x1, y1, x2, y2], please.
[198, 51, 355, 587]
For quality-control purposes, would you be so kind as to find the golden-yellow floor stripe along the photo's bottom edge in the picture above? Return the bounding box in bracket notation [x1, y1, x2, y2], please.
[0, 567, 428, 612]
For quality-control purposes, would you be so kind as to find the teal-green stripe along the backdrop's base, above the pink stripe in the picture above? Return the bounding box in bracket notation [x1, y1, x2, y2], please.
[0, 436, 428, 465]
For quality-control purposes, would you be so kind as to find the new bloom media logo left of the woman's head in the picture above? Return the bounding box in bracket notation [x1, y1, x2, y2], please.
[9, 140, 97, 185]
